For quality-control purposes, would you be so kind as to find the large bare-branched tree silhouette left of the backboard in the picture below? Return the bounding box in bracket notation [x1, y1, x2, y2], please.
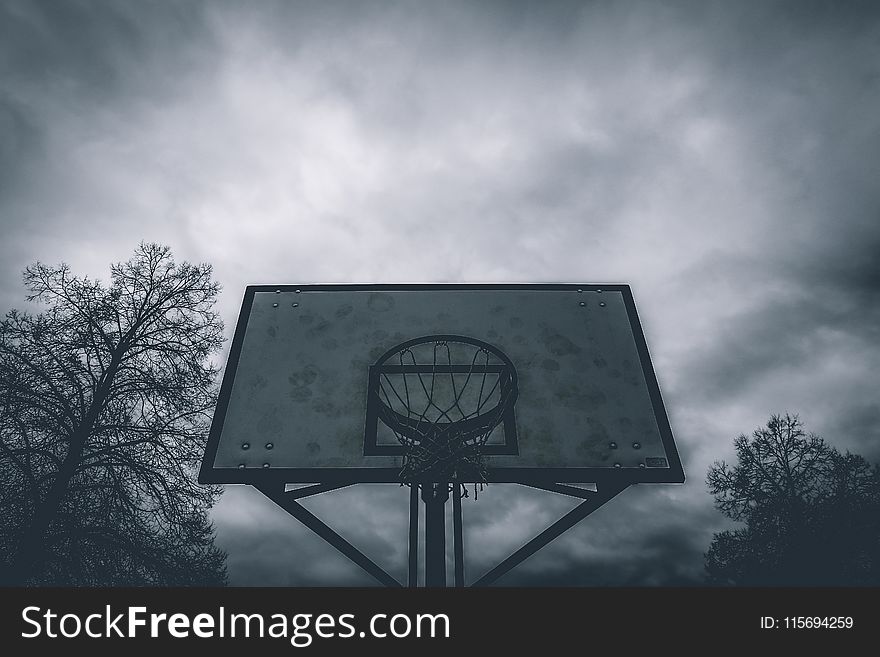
[0, 244, 226, 585]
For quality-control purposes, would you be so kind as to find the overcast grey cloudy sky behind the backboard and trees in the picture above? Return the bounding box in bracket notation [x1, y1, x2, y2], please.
[0, 0, 880, 585]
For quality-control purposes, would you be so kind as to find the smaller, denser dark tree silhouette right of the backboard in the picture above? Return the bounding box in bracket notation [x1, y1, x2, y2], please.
[706, 415, 880, 586]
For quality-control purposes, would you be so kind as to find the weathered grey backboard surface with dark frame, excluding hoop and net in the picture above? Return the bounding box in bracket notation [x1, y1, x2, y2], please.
[199, 284, 684, 483]
